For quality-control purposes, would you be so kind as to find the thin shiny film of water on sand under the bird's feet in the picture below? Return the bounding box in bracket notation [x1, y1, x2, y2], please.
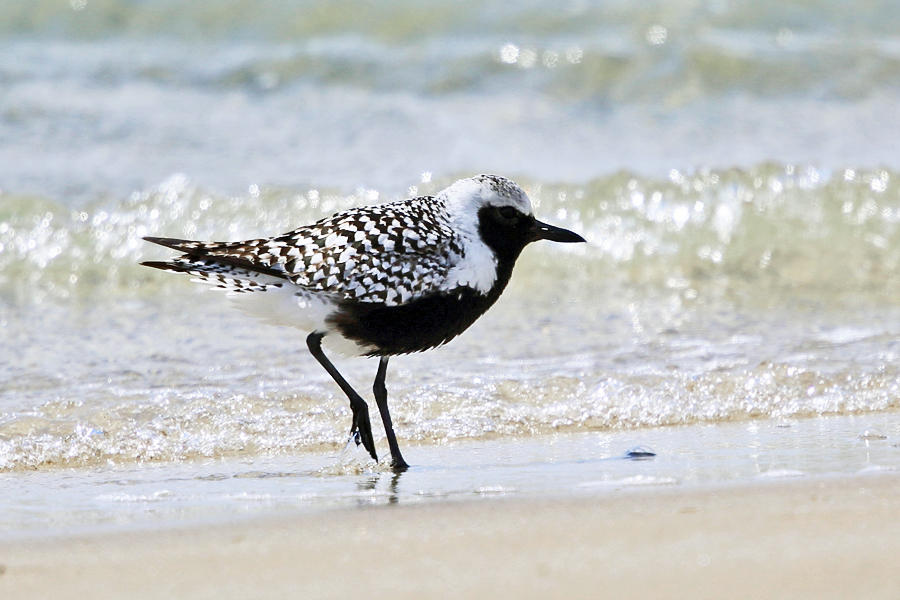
[0, 413, 900, 541]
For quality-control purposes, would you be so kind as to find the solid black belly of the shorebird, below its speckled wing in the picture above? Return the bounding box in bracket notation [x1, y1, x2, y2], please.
[330, 282, 505, 356]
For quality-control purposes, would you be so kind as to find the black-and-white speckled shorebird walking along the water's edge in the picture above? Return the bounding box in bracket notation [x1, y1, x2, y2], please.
[141, 174, 585, 472]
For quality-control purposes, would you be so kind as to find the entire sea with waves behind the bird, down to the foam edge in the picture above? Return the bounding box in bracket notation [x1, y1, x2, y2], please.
[0, 0, 900, 482]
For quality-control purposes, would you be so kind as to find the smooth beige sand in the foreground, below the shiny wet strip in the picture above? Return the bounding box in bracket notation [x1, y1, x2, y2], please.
[0, 473, 900, 599]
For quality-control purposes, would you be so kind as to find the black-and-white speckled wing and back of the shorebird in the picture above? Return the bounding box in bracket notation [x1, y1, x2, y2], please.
[176, 197, 461, 306]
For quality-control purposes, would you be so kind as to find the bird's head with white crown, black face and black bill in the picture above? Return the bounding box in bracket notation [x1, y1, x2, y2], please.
[440, 175, 585, 260]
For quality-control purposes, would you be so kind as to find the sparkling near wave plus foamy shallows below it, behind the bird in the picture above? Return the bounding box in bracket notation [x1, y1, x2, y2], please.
[0, 166, 900, 470]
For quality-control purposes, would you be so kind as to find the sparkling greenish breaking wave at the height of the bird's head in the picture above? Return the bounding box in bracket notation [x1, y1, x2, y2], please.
[0, 164, 900, 303]
